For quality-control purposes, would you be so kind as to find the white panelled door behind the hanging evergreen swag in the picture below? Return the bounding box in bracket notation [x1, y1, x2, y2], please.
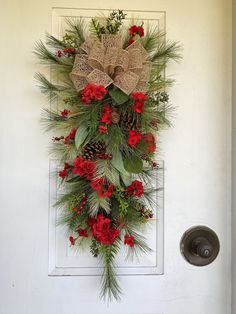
[0, 0, 232, 314]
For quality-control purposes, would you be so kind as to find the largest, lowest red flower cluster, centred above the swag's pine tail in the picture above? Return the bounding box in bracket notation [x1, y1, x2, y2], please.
[90, 214, 120, 245]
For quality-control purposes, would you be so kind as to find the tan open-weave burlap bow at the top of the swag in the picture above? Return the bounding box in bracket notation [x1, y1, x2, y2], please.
[70, 34, 152, 95]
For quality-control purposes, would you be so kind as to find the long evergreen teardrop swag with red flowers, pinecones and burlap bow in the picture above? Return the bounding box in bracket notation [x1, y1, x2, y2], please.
[35, 10, 180, 300]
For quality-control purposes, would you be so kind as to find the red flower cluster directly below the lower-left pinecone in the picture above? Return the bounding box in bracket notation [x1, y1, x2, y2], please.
[73, 156, 96, 181]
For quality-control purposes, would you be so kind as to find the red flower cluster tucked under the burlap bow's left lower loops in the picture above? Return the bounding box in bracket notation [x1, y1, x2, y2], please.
[81, 84, 107, 104]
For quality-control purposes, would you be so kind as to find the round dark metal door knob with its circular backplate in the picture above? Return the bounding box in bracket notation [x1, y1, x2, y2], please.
[180, 226, 220, 266]
